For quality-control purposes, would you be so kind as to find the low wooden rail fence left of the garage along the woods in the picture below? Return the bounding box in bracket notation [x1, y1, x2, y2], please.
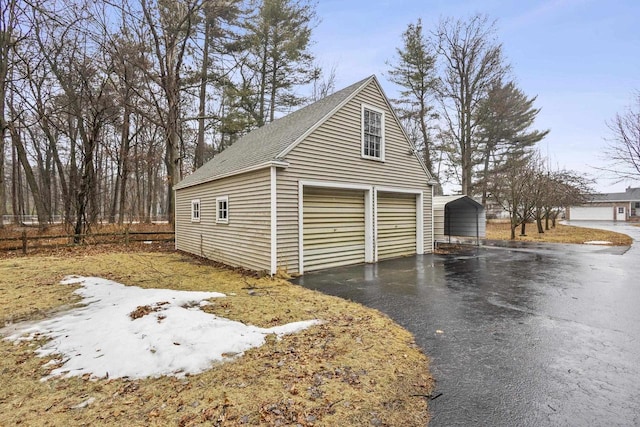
[0, 230, 175, 255]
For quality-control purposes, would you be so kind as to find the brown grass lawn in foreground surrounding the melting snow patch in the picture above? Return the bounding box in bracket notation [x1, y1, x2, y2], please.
[0, 246, 433, 426]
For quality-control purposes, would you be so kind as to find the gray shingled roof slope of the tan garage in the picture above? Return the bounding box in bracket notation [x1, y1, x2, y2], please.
[174, 76, 375, 189]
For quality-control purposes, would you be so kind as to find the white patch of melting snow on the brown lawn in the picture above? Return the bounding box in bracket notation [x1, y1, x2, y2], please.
[6, 276, 319, 380]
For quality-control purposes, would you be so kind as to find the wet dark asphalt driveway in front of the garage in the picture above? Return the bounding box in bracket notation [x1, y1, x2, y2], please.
[298, 223, 640, 426]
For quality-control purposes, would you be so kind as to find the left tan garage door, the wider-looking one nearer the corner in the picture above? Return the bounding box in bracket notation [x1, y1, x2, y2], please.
[303, 188, 365, 271]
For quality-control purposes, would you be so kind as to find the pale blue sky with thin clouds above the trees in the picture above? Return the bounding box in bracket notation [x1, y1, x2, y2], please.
[313, 0, 640, 192]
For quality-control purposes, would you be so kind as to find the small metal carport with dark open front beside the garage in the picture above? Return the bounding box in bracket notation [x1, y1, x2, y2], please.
[433, 195, 487, 245]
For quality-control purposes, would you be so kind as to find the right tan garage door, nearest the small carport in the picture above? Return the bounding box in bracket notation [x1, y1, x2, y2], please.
[377, 193, 417, 260]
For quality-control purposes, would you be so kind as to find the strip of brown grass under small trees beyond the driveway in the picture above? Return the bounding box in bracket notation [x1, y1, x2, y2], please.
[487, 221, 633, 246]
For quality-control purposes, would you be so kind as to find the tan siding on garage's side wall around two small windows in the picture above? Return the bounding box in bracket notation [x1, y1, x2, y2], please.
[176, 168, 271, 271]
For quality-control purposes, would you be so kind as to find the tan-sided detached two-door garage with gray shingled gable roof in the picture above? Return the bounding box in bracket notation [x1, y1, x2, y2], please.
[175, 76, 433, 274]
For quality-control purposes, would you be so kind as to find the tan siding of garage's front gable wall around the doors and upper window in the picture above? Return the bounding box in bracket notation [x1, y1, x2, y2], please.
[277, 81, 432, 272]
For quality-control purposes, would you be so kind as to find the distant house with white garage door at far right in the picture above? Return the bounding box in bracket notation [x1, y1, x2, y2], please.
[566, 187, 640, 221]
